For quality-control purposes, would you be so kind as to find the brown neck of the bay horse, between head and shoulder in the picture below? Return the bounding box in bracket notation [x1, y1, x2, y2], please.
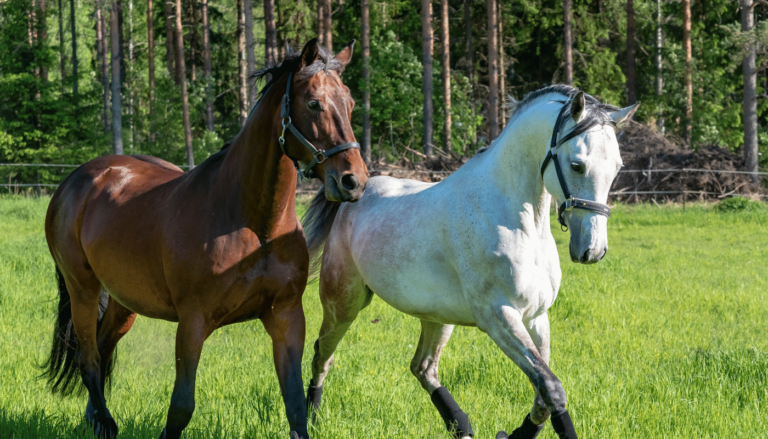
[221, 79, 297, 236]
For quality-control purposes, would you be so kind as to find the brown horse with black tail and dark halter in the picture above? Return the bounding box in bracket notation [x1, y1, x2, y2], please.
[40, 40, 368, 439]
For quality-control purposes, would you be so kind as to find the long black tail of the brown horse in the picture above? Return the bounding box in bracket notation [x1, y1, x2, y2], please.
[39, 267, 114, 396]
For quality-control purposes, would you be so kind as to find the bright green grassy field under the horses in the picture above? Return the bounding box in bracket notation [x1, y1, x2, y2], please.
[0, 197, 768, 439]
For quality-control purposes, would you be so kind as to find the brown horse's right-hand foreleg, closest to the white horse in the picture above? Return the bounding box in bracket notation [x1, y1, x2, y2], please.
[262, 302, 309, 439]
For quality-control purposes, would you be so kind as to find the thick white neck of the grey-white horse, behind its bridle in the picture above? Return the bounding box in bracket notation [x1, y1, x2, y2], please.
[482, 94, 564, 234]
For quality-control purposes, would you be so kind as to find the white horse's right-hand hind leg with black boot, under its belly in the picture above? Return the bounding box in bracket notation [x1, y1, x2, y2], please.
[411, 320, 474, 438]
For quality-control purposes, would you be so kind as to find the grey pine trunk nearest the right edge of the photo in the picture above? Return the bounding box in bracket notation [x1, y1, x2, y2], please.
[741, 0, 760, 183]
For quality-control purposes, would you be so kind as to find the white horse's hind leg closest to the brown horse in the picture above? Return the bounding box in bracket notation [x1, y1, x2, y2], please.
[307, 272, 373, 421]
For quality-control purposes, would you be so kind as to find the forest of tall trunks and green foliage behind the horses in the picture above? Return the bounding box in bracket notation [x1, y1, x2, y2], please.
[0, 0, 768, 183]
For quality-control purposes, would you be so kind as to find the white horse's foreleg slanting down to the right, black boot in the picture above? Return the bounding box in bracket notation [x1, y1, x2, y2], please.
[486, 306, 577, 439]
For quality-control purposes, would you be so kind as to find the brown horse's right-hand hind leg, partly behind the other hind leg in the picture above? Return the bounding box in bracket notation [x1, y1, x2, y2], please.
[85, 289, 136, 424]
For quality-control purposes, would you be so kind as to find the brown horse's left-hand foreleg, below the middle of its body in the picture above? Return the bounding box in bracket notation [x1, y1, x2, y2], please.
[160, 315, 210, 439]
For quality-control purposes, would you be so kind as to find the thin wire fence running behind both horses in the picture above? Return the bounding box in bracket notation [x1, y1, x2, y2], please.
[0, 163, 768, 199]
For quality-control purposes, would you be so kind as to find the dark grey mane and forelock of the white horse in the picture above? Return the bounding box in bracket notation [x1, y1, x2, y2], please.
[507, 84, 619, 148]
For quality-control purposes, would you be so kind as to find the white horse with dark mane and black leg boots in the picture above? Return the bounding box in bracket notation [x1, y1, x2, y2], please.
[305, 85, 637, 439]
